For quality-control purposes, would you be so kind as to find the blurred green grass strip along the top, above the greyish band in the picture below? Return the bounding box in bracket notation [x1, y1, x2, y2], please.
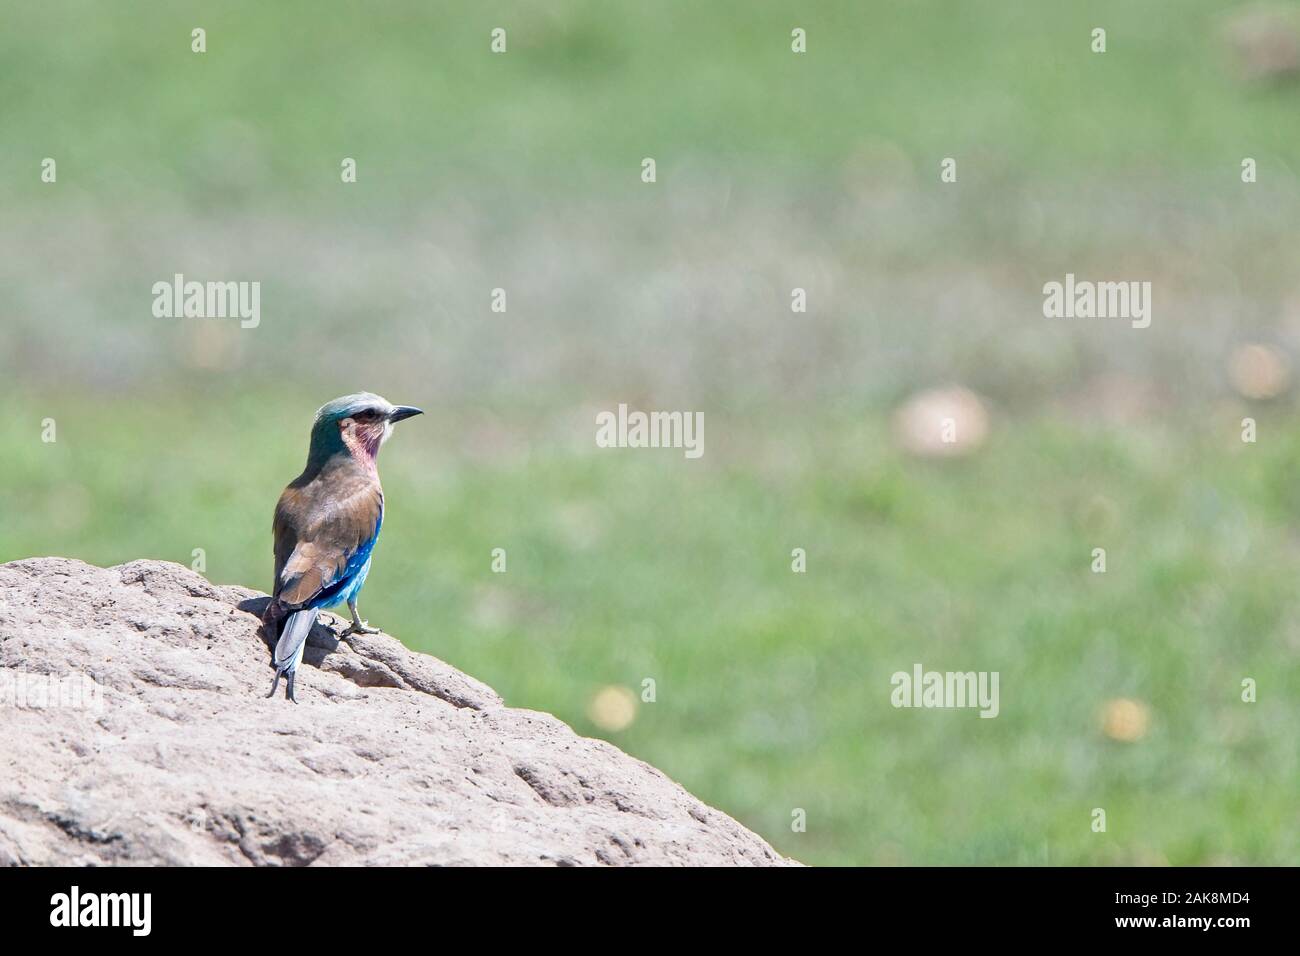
[0, 0, 1297, 211]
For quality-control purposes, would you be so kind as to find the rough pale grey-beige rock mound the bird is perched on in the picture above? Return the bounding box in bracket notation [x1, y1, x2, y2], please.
[0, 558, 792, 865]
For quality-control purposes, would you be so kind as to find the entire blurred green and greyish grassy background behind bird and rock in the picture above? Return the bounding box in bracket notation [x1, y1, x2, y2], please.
[0, 0, 1300, 864]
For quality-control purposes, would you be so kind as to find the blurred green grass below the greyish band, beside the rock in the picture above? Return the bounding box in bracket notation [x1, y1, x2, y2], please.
[0, 395, 1300, 864]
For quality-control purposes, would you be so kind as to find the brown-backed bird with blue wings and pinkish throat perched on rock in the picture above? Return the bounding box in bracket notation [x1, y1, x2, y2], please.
[263, 392, 424, 704]
